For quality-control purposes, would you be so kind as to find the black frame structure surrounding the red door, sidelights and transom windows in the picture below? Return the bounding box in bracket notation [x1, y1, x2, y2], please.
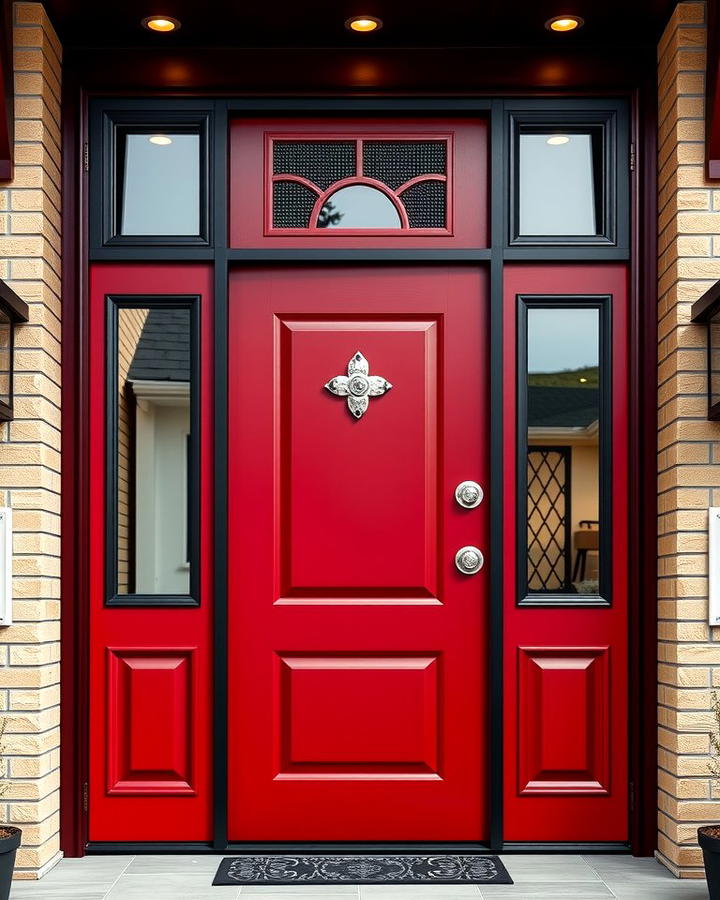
[63, 93, 656, 855]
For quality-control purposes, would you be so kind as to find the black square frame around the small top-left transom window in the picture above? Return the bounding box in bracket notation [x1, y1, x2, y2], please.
[89, 99, 214, 251]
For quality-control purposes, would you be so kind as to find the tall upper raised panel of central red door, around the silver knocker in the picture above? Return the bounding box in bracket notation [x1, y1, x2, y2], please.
[276, 317, 440, 601]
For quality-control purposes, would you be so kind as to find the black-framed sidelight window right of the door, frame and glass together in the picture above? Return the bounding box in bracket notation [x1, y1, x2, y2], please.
[518, 297, 610, 604]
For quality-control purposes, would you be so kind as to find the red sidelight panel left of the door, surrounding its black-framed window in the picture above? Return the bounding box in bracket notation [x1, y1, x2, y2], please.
[89, 264, 213, 841]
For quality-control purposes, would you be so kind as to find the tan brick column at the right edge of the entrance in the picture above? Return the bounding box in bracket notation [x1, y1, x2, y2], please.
[658, 2, 720, 877]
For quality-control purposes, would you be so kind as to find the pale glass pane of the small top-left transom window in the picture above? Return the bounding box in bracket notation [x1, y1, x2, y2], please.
[118, 132, 200, 235]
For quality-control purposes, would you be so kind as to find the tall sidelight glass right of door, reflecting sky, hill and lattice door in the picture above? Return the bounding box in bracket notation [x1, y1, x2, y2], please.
[527, 307, 601, 595]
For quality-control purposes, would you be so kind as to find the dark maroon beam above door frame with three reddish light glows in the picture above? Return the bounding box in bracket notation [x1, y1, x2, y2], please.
[65, 47, 655, 96]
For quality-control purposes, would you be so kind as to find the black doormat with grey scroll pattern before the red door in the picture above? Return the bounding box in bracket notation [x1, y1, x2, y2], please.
[213, 855, 513, 884]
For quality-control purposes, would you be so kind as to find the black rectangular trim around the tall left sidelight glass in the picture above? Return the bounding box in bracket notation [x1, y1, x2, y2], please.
[105, 294, 201, 607]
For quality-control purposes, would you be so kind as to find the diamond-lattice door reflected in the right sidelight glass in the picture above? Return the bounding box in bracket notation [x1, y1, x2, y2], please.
[527, 446, 572, 593]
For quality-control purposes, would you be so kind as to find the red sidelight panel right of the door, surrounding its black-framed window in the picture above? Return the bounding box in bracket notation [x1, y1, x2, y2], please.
[503, 265, 628, 841]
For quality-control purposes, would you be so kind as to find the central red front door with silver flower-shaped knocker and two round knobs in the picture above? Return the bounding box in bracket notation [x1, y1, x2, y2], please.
[228, 266, 488, 841]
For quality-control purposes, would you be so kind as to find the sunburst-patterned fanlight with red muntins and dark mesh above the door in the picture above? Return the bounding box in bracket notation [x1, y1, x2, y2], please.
[268, 136, 450, 234]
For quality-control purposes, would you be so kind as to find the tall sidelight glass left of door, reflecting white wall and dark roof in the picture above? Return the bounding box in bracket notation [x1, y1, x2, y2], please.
[117, 307, 191, 595]
